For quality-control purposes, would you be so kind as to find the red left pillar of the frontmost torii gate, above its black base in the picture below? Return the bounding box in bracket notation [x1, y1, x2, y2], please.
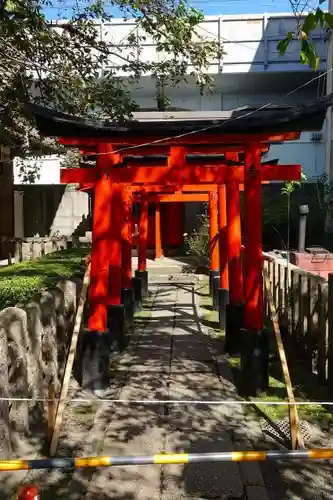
[88, 144, 112, 332]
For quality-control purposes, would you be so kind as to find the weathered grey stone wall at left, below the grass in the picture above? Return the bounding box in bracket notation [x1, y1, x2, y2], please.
[0, 278, 82, 459]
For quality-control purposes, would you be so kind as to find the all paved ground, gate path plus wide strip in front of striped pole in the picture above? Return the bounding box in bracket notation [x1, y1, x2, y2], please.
[3, 276, 333, 500]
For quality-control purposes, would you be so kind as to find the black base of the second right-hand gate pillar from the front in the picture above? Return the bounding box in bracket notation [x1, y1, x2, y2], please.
[224, 304, 244, 355]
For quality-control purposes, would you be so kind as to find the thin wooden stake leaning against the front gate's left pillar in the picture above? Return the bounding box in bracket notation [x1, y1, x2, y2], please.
[50, 263, 91, 457]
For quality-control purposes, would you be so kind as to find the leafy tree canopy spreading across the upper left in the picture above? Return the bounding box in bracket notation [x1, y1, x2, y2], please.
[0, 0, 222, 158]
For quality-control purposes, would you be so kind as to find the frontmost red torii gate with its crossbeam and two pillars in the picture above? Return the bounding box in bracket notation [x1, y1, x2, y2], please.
[61, 142, 301, 398]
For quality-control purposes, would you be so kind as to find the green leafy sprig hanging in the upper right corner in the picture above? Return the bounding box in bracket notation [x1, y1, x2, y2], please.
[277, 4, 333, 70]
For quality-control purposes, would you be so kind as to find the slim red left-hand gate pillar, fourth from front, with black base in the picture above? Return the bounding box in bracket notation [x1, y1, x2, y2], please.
[135, 195, 148, 298]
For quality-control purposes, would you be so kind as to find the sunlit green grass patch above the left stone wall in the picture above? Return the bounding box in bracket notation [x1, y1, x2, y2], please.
[0, 248, 89, 310]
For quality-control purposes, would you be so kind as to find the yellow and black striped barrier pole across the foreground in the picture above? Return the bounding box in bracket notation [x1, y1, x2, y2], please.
[0, 448, 333, 472]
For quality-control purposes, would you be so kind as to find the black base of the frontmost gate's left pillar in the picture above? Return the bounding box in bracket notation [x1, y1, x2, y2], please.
[80, 330, 112, 394]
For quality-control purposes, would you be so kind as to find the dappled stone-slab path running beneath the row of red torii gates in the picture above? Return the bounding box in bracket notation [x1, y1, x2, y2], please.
[58, 283, 268, 500]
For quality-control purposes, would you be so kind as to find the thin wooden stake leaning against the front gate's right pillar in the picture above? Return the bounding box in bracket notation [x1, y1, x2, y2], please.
[263, 269, 304, 450]
